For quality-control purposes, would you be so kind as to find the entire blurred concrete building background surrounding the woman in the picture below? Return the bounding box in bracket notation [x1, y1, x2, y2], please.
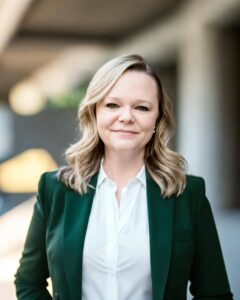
[0, 0, 240, 300]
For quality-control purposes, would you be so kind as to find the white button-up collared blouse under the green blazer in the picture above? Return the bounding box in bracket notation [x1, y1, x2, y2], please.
[82, 166, 152, 300]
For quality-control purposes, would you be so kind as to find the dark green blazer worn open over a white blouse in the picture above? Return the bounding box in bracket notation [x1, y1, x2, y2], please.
[15, 172, 233, 300]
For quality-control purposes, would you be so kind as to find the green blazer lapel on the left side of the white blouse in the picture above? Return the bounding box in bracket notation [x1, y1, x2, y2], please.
[62, 174, 98, 299]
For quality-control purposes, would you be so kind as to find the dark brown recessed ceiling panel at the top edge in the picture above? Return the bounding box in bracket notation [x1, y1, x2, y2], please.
[20, 0, 181, 40]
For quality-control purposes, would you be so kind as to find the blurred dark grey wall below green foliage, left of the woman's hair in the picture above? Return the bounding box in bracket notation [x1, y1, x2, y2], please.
[8, 109, 79, 165]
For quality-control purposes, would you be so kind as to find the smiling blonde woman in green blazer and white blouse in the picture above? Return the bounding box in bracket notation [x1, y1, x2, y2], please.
[15, 55, 232, 300]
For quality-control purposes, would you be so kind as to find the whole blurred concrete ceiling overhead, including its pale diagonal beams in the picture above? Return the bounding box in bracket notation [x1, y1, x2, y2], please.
[0, 0, 240, 101]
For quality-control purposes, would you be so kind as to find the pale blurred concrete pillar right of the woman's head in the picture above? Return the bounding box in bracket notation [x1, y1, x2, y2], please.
[177, 27, 222, 206]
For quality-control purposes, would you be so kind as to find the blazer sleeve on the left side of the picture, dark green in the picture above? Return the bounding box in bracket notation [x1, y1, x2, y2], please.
[15, 176, 52, 300]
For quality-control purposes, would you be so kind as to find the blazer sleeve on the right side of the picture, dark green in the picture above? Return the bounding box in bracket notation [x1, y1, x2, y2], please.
[190, 178, 233, 300]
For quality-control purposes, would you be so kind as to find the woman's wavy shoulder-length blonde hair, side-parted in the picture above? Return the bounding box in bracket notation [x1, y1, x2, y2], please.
[59, 55, 186, 197]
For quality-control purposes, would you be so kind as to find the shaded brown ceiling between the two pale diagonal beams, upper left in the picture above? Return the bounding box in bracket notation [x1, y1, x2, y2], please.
[0, 0, 184, 99]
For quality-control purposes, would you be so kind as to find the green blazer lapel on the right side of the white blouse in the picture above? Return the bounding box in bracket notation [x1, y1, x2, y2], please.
[147, 174, 174, 300]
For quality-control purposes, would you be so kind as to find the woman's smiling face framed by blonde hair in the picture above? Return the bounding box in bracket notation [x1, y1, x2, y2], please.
[96, 71, 159, 154]
